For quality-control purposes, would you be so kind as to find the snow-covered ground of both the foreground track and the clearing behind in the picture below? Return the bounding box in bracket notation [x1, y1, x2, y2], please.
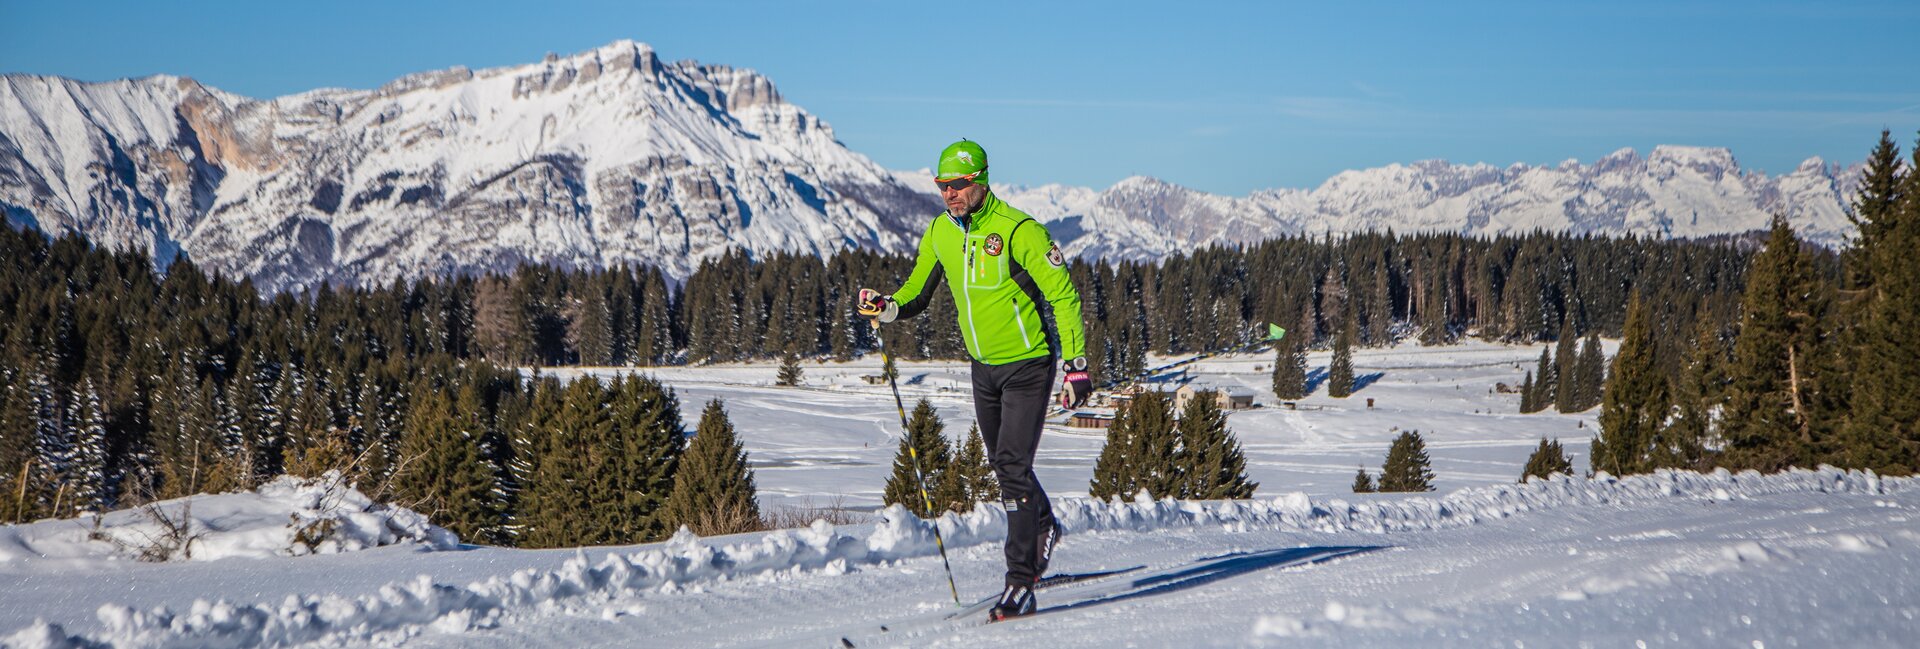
[0, 346, 1920, 647]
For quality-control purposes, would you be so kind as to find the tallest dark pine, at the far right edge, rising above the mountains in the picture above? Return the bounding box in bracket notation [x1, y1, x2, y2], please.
[1843, 132, 1920, 474]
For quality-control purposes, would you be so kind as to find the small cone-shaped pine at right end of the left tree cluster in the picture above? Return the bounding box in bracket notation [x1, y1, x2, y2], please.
[664, 399, 762, 536]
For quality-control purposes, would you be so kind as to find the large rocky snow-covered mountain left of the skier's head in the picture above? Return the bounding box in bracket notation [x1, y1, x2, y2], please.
[0, 40, 939, 288]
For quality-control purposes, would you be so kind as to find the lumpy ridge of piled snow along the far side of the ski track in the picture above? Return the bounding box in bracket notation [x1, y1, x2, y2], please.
[6, 467, 1912, 647]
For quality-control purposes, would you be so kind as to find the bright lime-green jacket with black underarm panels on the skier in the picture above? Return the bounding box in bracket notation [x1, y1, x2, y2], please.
[893, 192, 1087, 365]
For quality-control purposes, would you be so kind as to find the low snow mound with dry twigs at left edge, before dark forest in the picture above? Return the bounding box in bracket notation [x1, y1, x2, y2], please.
[0, 472, 459, 563]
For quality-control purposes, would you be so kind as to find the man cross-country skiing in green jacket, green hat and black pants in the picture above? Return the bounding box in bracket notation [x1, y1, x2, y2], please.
[858, 140, 1092, 620]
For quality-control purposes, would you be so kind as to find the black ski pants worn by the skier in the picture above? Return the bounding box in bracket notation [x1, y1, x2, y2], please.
[973, 355, 1058, 584]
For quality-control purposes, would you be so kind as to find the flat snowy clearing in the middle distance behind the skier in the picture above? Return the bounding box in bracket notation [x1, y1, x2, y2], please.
[555, 342, 1613, 509]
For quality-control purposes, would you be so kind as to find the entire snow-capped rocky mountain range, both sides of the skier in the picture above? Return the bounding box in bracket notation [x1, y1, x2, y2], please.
[0, 40, 1864, 290]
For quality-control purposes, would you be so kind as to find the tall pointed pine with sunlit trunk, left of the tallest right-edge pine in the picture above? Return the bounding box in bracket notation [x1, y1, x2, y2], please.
[1724, 217, 1824, 470]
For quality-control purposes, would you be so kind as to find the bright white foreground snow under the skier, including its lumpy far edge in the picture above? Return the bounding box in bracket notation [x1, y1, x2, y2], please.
[6, 467, 1920, 647]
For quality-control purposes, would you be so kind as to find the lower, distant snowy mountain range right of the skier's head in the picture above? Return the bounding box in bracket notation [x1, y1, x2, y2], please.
[1000, 146, 1860, 259]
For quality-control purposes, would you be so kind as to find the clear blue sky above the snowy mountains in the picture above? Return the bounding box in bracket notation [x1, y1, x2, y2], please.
[0, 0, 1920, 194]
